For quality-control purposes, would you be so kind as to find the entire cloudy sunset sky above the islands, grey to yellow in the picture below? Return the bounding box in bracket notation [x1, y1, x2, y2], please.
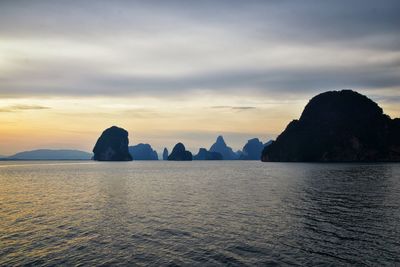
[0, 0, 400, 155]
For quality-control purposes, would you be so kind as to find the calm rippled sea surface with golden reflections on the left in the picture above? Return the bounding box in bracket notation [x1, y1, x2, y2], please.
[0, 161, 400, 266]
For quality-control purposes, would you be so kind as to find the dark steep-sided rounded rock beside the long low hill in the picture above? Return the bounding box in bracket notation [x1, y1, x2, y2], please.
[93, 126, 132, 161]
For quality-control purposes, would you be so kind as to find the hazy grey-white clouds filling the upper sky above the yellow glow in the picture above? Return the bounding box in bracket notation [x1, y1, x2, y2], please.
[0, 0, 400, 97]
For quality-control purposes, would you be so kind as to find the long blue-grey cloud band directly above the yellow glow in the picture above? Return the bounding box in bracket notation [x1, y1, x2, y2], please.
[0, 60, 400, 98]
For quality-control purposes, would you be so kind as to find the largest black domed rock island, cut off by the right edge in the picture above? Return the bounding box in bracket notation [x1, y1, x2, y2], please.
[262, 90, 400, 162]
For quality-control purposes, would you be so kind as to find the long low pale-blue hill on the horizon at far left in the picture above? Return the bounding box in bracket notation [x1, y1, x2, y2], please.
[6, 149, 93, 160]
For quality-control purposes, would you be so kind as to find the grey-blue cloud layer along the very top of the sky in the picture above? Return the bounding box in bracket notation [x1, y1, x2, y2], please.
[0, 0, 400, 41]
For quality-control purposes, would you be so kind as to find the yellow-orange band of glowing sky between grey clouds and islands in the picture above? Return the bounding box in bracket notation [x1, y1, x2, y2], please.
[0, 92, 400, 155]
